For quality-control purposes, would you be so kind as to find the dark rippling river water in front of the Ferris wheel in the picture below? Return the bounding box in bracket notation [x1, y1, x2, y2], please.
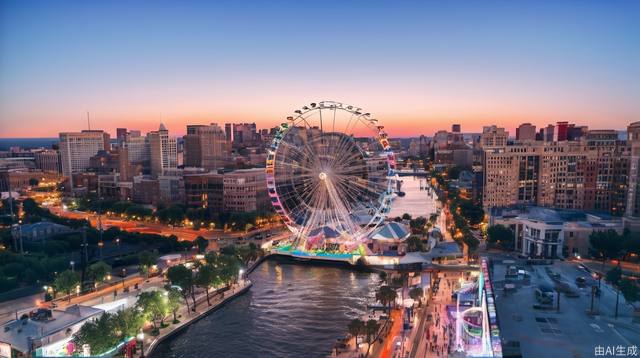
[152, 260, 379, 358]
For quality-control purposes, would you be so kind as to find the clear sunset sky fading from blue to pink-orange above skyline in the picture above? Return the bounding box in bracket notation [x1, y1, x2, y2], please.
[0, 0, 640, 137]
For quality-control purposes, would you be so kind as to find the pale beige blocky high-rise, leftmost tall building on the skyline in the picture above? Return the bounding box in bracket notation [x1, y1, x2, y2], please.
[60, 130, 110, 187]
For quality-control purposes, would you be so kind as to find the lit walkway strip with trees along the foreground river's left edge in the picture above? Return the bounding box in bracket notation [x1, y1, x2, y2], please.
[144, 279, 253, 356]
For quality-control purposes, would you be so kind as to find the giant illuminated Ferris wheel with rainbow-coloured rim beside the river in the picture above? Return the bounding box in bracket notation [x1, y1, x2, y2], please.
[266, 101, 396, 250]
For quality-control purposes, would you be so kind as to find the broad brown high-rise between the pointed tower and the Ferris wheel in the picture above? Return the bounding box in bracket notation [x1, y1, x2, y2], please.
[184, 123, 229, 170]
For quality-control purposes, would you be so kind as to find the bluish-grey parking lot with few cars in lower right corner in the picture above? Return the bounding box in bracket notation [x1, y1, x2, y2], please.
[492, 259, 640, 357]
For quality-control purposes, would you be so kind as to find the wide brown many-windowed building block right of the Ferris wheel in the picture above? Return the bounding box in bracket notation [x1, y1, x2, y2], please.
[483, 130, 629, 215]
